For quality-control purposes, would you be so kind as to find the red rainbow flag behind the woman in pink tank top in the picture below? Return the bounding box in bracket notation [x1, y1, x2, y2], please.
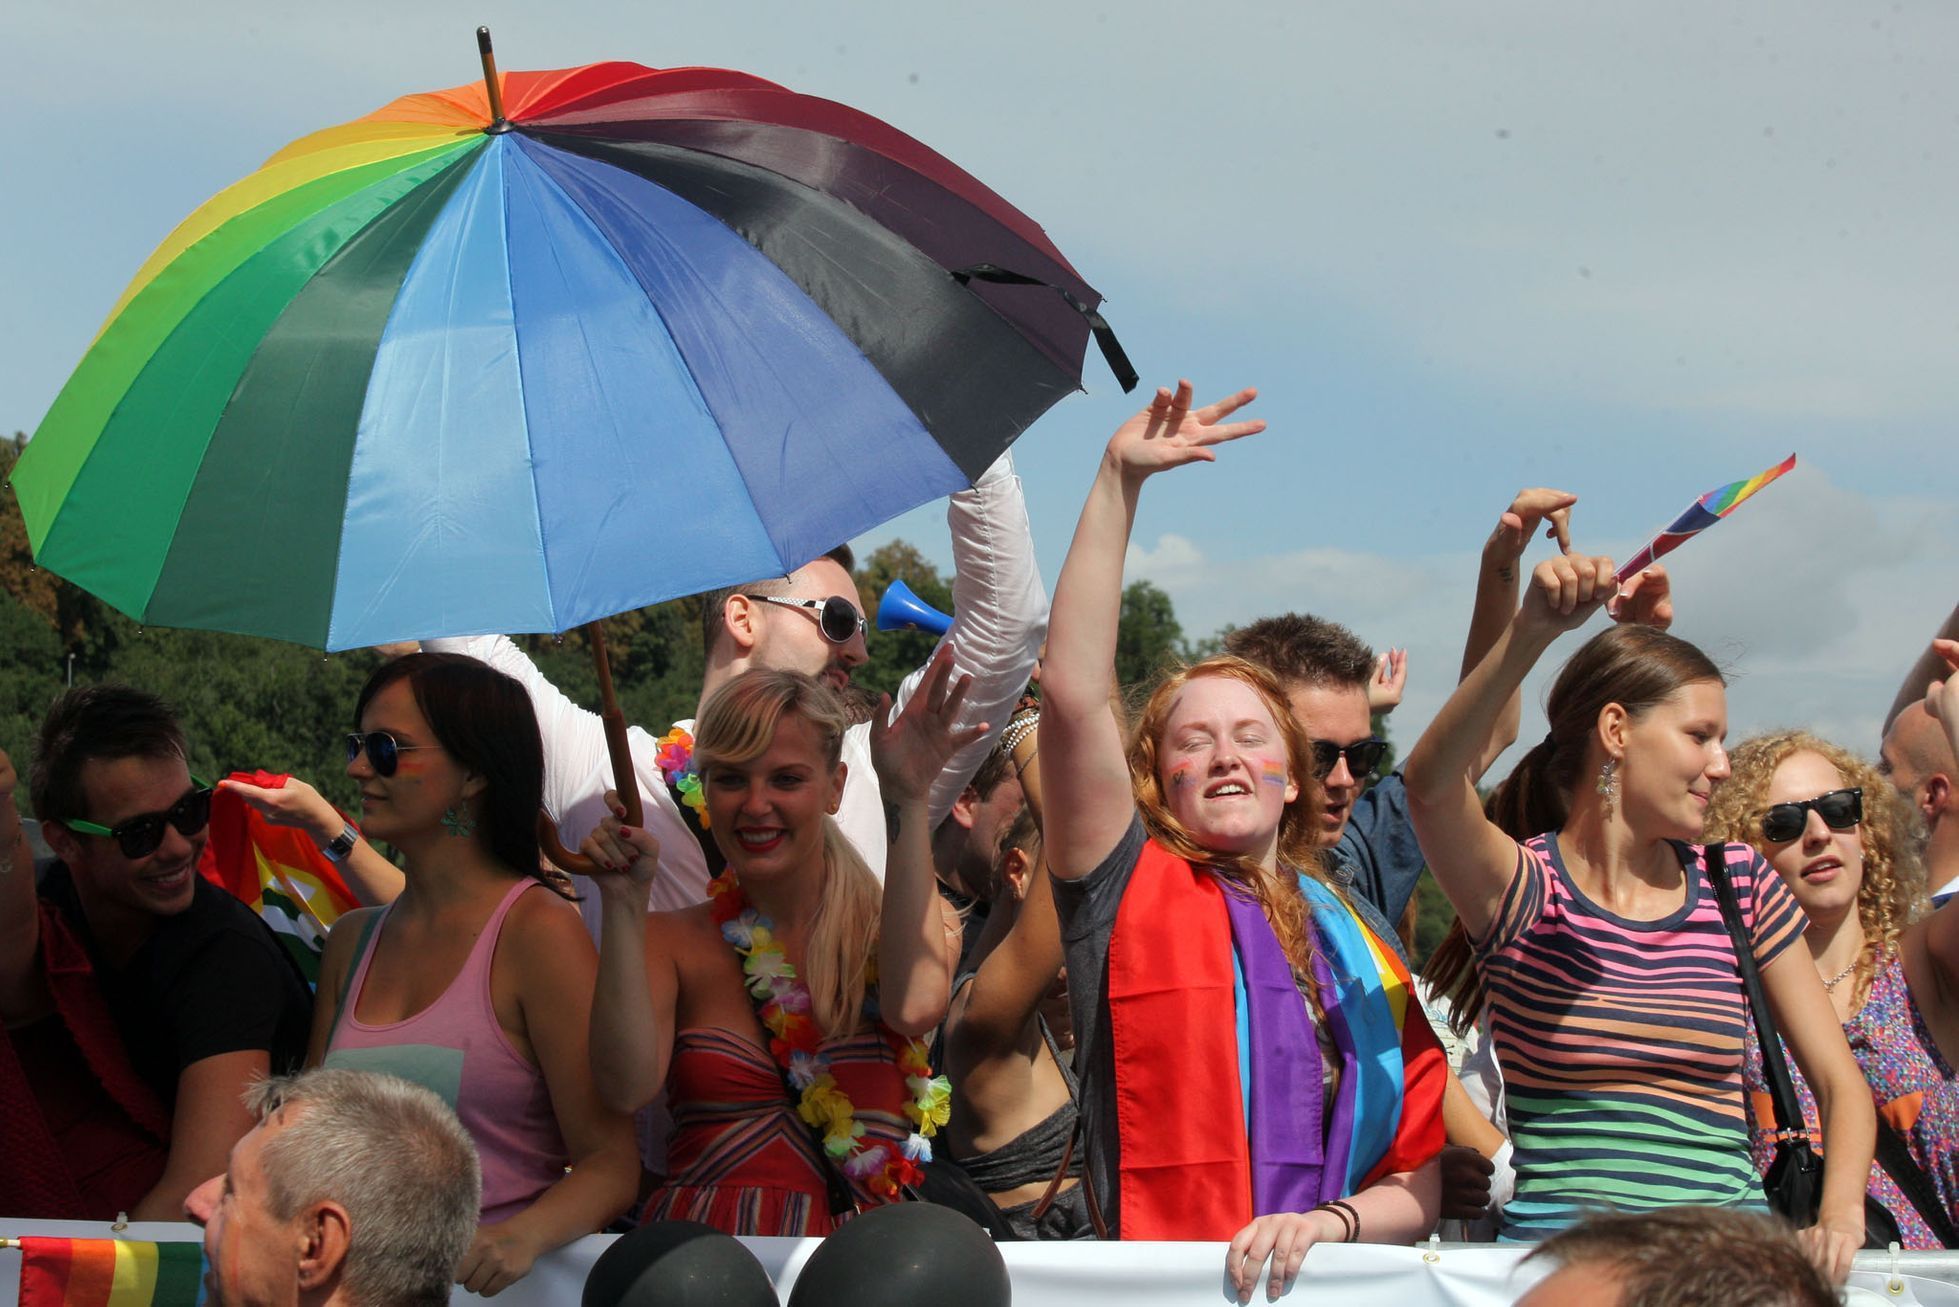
[198, 772, 360, 986]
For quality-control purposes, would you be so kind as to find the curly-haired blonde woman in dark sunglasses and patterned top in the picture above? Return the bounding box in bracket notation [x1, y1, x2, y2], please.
[1708, 693, 1959, 1248]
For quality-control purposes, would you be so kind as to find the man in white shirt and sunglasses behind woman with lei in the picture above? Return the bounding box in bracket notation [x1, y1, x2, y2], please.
[423, 455, 1048, 920]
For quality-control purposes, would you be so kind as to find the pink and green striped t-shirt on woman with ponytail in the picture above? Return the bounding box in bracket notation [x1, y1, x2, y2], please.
[1477, 835, 1806, 1240]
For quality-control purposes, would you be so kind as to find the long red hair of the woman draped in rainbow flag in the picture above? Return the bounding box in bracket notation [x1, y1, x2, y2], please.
[1128, 654, 1344, 1021]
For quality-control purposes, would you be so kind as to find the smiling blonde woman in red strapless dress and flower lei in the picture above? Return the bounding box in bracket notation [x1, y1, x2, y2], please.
[582, 649, 985, 1234]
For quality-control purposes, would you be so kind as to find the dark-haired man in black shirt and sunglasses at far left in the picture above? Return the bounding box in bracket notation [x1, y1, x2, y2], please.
[0, 686, 311, 1221]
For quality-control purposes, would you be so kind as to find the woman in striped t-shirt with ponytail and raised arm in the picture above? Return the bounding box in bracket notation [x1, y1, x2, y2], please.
[1405, 555, 1875, 1280]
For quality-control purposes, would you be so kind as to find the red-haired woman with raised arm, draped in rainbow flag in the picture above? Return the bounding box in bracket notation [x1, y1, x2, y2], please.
[1040, 384, 1444, 1301]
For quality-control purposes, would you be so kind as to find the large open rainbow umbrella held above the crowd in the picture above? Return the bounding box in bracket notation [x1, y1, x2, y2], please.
[14, 31, 1134, 649]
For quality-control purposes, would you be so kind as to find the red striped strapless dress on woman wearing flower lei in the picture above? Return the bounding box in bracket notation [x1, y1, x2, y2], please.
[641, 1027, 911, 1234]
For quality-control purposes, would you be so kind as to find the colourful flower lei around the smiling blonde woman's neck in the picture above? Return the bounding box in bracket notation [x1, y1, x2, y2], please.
[707, 870, 952, 1203]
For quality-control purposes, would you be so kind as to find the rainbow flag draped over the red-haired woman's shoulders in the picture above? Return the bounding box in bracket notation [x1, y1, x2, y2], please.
[1107, 841, 1446, 1240]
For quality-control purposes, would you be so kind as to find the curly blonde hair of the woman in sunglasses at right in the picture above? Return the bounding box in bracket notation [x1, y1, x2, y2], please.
[1704, 731, 1928, 993]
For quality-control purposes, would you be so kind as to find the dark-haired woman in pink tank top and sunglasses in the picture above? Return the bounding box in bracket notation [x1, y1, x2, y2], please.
[308, 653, 639, 1293]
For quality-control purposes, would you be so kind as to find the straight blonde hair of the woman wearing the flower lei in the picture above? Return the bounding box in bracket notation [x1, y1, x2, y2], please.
[693, 668, 884, 1039]
